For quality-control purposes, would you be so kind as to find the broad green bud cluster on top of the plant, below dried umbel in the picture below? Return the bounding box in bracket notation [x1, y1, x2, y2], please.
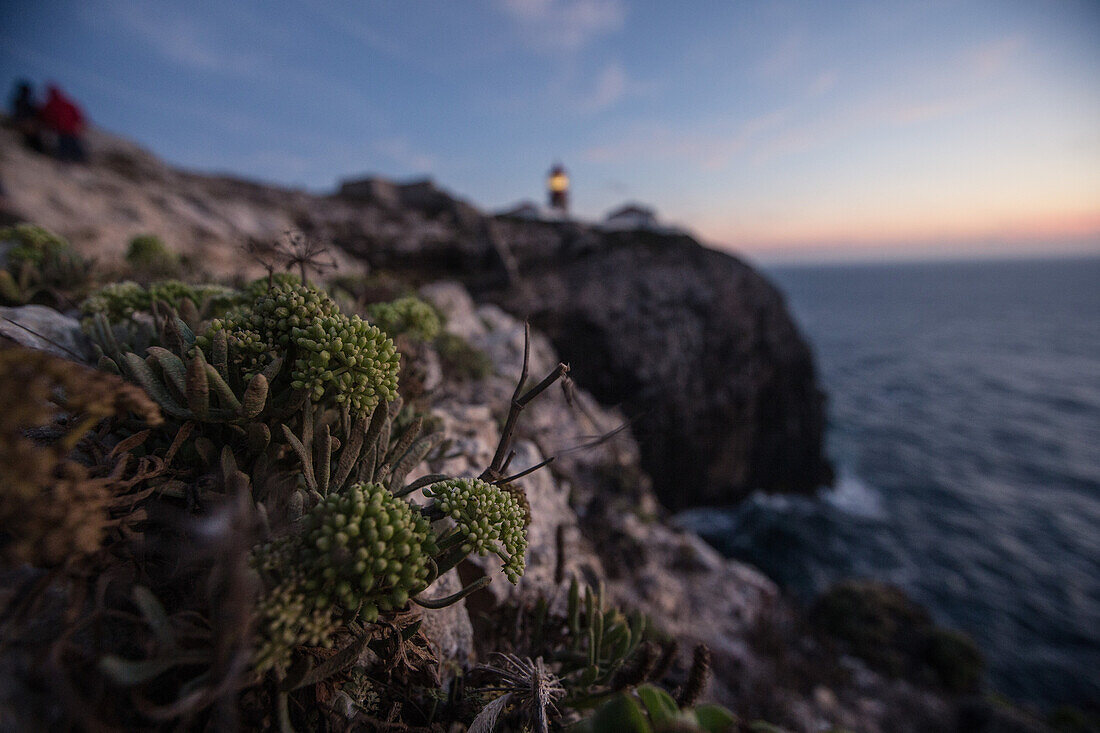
[198, 283, 398, 413]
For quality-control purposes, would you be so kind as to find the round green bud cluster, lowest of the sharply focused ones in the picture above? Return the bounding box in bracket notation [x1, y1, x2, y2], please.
[257, 483, 436, 622]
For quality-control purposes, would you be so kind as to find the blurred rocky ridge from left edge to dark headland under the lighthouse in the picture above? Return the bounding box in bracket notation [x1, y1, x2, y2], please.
[0, 125, 832, 508]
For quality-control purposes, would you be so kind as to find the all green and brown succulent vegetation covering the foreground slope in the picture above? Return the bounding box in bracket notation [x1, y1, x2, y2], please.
[0, 227, 735, 731]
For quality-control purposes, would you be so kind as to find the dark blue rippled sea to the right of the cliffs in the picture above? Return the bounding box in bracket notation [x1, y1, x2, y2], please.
[683, 259, 1100, 707]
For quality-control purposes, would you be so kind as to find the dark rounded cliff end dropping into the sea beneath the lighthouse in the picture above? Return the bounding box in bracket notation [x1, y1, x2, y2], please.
[490, 222, 832, 508]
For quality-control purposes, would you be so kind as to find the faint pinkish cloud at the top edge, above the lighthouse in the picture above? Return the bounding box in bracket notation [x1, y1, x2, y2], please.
[499, 0, 626, 51]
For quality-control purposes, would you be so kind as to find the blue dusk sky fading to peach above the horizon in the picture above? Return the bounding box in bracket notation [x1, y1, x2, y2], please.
[0, 0, 1100, 261]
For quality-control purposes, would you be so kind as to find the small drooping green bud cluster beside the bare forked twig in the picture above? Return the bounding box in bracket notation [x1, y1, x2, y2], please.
[424, 479, 527, 583]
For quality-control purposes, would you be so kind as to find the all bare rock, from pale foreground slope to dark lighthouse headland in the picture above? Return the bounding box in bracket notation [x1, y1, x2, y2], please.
[0, 122, 1038, 732]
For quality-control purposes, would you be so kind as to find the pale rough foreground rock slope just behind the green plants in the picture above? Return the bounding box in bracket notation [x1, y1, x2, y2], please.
[0, 282, 976, 733]
